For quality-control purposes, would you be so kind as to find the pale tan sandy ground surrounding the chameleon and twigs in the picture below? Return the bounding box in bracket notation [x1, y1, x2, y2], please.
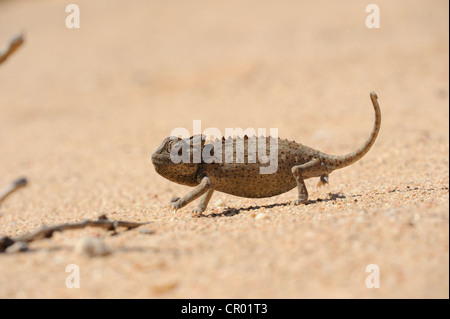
[0, 0, 449, 298]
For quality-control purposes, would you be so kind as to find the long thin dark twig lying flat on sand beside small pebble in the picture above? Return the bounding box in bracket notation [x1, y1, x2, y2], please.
[0, 215, 148, 253]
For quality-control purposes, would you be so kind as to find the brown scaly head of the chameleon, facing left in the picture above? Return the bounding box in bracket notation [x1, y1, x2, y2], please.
[152, 136, 204, 186]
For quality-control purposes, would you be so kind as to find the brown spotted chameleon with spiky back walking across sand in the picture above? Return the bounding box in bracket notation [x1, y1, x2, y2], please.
[151, 92, 381, 213]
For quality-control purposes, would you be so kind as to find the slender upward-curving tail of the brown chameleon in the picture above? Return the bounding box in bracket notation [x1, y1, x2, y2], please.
[329, 91, 381, 170]
